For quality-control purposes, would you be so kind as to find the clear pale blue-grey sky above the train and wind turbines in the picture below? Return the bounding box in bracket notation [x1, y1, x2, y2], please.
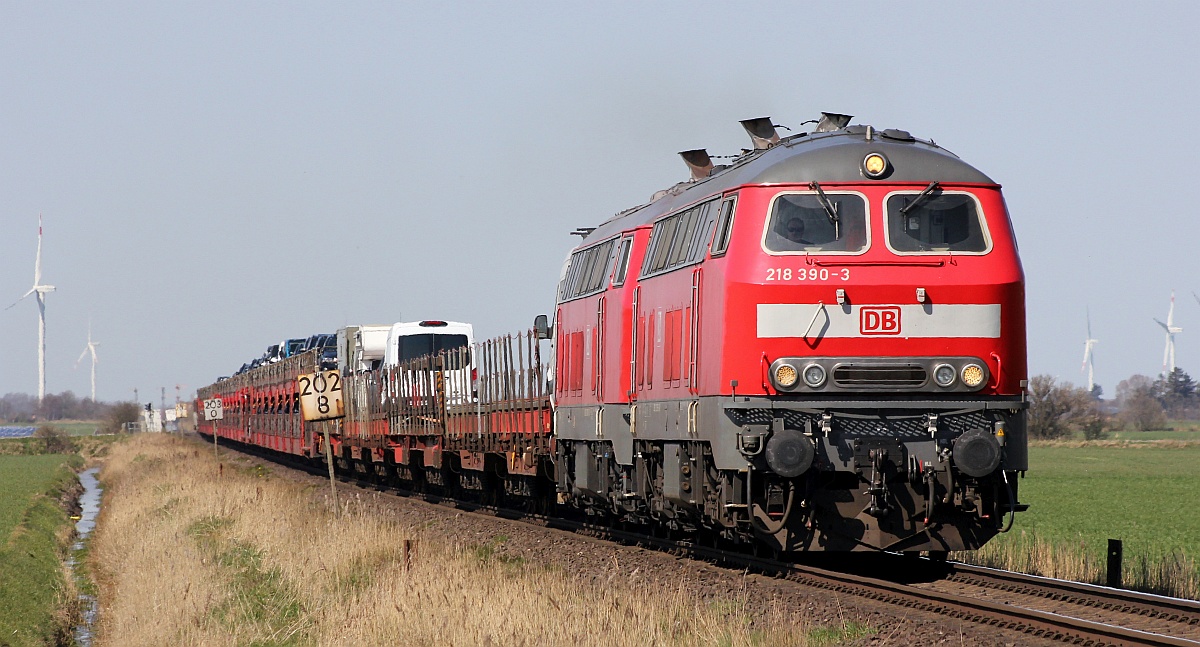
[0, 0, 1200, 401]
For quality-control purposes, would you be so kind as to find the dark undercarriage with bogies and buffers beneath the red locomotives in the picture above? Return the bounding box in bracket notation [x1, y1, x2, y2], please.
[558, 397, 1027, 551]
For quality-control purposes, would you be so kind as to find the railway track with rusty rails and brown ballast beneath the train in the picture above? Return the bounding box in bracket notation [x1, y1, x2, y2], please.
[213, 434, 1200, 647]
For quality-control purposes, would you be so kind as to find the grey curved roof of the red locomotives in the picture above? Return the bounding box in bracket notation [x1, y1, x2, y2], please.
[583, 126, 995, 245]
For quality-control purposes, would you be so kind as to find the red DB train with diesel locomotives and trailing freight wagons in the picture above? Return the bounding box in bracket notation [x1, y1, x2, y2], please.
[198, 113, 1027, 555]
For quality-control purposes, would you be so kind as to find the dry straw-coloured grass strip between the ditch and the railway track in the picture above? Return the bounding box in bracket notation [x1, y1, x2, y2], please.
[91, 435, 862, 646]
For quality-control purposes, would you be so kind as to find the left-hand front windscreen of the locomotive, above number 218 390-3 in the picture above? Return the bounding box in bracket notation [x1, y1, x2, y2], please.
[762, 192, 869, 253]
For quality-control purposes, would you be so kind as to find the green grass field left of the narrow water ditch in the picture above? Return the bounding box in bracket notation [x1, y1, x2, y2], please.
[0, 453, 83, 646]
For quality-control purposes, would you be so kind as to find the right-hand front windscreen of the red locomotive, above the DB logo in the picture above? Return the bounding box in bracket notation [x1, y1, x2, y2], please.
[887, 192, 991, 253]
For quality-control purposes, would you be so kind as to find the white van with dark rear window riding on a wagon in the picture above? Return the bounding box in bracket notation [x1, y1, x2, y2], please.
[383, 320, 478, 405]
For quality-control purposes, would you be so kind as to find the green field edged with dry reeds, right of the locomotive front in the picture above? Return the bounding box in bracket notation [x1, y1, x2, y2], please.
[959, 439, 1200, 599]
